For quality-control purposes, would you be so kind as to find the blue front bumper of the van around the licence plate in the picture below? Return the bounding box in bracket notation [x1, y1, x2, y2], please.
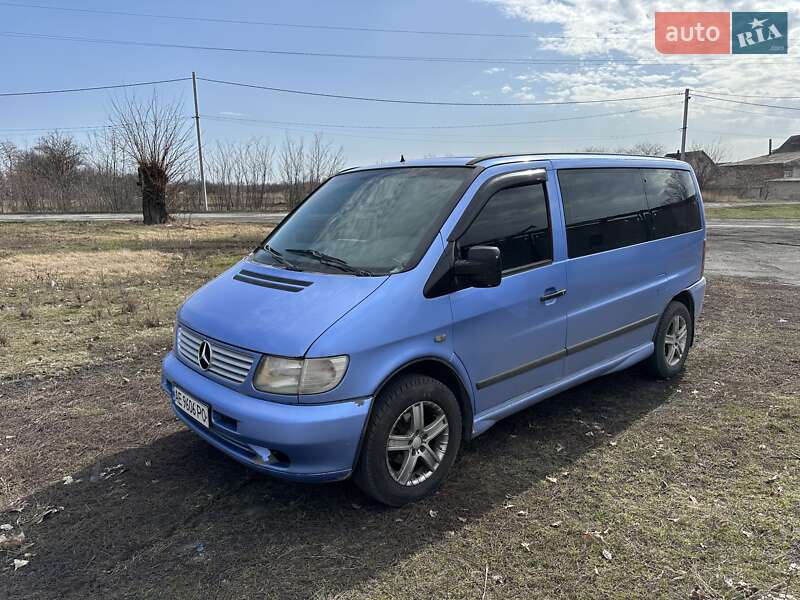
[161, 352, 372, 481]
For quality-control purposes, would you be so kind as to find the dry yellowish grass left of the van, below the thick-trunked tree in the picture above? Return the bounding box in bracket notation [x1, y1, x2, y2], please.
[0, 223, 268, 380]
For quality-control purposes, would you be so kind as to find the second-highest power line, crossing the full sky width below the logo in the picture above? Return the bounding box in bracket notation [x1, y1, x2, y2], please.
[0, 31, 800, 67]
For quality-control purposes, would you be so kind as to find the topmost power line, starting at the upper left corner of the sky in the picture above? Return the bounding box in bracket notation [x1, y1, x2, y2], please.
[0, 2, 628, 40]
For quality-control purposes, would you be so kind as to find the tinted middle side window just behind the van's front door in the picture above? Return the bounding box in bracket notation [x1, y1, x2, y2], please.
[558, 169, 648, 258]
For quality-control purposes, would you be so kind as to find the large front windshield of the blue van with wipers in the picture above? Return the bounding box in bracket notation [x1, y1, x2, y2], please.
[253, 167, 474, 275]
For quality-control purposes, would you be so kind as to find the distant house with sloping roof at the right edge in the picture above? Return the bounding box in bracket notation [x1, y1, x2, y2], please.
[704, 135, 800, 201]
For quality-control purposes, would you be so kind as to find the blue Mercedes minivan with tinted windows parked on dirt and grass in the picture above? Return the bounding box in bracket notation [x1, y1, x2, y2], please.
[162, 154, 706, 506]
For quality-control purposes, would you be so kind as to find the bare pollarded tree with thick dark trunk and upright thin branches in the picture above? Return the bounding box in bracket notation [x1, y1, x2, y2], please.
[110, 92, 193, 225]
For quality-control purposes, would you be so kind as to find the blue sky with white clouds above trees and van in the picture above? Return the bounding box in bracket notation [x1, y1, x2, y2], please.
[0, 0, 800, 165]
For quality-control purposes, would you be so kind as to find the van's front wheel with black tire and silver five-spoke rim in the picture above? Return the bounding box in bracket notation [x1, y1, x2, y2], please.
[355, 374, 461, 506]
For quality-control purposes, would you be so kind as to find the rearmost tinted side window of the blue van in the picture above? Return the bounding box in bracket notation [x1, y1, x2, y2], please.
[642, 169, 700, 239]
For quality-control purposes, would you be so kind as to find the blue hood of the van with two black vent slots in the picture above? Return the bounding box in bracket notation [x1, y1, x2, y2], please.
[178, 259, 388, 357]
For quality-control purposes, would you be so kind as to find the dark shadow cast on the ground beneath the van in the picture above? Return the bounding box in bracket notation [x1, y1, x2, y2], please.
[0, 369, 680, 598]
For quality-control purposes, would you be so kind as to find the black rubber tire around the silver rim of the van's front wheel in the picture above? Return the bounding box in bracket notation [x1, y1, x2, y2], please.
[354, 373, 462, 506]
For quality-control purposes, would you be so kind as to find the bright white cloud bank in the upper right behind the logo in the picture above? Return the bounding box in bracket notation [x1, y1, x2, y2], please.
[484, 0, 800, 155]
